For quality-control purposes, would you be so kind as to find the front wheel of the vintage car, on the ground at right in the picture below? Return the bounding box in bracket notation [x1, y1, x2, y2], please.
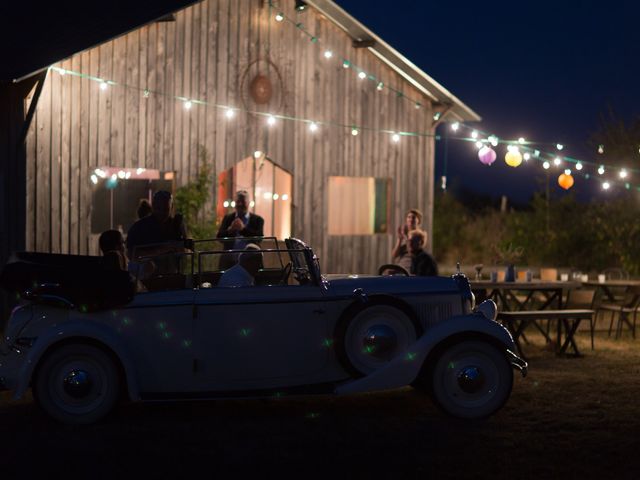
[429, 340, 513, 419]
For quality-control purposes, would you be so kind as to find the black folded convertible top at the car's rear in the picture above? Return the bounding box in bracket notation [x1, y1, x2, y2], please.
[0, 252, 135, 311]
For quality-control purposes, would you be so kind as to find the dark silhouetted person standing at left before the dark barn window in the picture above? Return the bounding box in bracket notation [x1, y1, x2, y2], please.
[127, 190, 186, 260]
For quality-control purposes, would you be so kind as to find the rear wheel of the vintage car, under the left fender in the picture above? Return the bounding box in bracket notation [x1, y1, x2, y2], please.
[33, 344, 120, 424]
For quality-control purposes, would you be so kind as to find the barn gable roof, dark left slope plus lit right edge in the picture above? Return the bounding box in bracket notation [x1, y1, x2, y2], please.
[0, 0, 480, 121]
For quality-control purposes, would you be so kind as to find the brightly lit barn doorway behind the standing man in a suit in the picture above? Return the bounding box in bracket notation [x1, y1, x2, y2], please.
[216, 152, 293, 238]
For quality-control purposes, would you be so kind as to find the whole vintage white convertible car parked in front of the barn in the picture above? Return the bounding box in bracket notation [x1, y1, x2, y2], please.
[0, 237, 527, 423]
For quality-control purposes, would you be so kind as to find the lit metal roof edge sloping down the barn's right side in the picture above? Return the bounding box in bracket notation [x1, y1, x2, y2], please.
[306, 0, 481, 122]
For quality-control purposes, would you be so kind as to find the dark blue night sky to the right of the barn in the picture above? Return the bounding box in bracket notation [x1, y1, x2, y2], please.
[338, 0, 640, 202]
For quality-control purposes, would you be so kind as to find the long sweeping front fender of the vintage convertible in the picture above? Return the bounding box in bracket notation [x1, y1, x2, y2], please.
[335, 313, 515, 395]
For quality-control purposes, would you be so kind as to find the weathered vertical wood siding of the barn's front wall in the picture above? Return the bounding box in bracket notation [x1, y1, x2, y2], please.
[26, 0, 434, 272]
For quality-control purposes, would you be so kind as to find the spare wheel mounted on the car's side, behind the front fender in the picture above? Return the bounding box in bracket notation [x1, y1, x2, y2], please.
[336, 305, 418, 377]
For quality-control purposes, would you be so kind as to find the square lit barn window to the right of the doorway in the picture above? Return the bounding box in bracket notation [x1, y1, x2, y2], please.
[329, 177, 391, 235]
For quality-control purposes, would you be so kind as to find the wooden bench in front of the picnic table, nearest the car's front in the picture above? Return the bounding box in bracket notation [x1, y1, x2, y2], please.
[498, 309, 595, 359]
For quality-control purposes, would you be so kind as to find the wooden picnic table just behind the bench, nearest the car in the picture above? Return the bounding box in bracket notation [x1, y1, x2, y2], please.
[470, 280, 581, 311]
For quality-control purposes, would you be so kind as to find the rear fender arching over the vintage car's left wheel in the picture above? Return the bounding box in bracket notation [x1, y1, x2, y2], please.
[13, 320, 140, 401]
